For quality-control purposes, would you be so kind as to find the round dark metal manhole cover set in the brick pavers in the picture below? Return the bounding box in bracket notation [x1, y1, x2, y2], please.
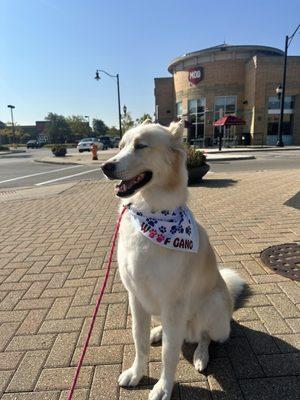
[260, 243, 300, 281]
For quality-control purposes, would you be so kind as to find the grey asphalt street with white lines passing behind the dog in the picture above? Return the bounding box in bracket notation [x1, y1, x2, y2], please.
[0, 149, 300, 188]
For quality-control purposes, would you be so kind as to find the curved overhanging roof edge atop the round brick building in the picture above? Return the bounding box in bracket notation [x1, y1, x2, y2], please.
[168, 43, 284, 73]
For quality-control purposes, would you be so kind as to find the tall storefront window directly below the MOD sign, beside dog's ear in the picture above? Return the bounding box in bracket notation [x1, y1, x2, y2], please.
[188, 97, 205, 146]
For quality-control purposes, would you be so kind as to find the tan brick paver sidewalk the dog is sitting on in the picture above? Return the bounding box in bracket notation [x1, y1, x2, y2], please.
[0, 170, 300, 400]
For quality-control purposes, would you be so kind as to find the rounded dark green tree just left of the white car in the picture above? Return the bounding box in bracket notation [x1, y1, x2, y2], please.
[43, 112, 72, 143]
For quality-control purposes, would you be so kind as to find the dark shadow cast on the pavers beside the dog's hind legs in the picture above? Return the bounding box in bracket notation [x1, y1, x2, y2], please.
[128, 287, 300, 400]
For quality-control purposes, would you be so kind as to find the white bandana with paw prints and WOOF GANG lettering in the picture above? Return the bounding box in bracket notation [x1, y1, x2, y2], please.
[128, 205, 199, 253]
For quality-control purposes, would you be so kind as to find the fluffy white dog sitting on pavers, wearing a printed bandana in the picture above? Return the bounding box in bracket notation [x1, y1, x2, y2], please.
[102, 121, 243, 400]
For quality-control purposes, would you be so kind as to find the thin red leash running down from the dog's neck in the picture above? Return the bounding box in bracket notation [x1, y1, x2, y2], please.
[67, 207, 126, 400]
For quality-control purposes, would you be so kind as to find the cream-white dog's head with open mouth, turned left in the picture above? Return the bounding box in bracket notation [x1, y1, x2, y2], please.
[102, 120, 187, 197]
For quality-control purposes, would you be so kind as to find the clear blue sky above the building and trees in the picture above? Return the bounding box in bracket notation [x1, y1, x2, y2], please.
[0, 0, 300, 125]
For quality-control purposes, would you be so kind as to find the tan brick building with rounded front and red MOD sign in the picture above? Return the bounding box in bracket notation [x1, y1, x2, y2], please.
[154, 44, 300, 146]
